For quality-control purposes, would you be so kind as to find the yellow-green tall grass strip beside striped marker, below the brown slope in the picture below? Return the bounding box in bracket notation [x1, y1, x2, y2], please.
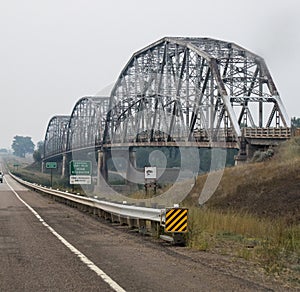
[188, 207, 300, 273]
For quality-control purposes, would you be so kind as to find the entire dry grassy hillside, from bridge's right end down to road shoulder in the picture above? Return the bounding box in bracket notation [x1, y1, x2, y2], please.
[183, 137, 300, 287]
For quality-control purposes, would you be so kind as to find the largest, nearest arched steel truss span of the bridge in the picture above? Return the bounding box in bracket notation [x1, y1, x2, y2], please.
[104, 37, 288, 144]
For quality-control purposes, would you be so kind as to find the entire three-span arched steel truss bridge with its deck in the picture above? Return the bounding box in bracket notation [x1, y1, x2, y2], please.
[44, 37, 290, 161]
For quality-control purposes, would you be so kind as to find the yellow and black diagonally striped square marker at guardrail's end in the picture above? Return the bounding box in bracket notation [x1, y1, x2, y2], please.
[165, 208, 188, 232]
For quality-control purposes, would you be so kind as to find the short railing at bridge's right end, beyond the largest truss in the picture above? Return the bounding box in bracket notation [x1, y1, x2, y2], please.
[243, 128, 291, 139]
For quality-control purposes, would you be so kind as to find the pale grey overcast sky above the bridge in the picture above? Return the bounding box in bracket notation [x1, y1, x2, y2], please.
[0, 0, 300, 148]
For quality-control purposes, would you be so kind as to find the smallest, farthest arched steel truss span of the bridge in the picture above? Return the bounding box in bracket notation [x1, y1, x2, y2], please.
[44, 116, 70, 158]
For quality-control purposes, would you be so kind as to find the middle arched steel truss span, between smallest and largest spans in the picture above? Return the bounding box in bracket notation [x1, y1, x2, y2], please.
[66, 97, 109, 151]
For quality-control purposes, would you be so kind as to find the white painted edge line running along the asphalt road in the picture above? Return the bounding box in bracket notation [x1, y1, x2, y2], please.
[5, 178, 126, 292]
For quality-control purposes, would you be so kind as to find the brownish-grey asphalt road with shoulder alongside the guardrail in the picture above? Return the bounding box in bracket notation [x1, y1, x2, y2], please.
[0, 175, 288, 292]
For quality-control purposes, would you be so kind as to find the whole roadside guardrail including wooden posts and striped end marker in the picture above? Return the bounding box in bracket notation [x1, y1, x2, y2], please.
[9, 173, 191, 246]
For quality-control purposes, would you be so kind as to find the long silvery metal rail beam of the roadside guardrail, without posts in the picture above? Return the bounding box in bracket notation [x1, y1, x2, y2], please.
[10, 173, 166, 224]
